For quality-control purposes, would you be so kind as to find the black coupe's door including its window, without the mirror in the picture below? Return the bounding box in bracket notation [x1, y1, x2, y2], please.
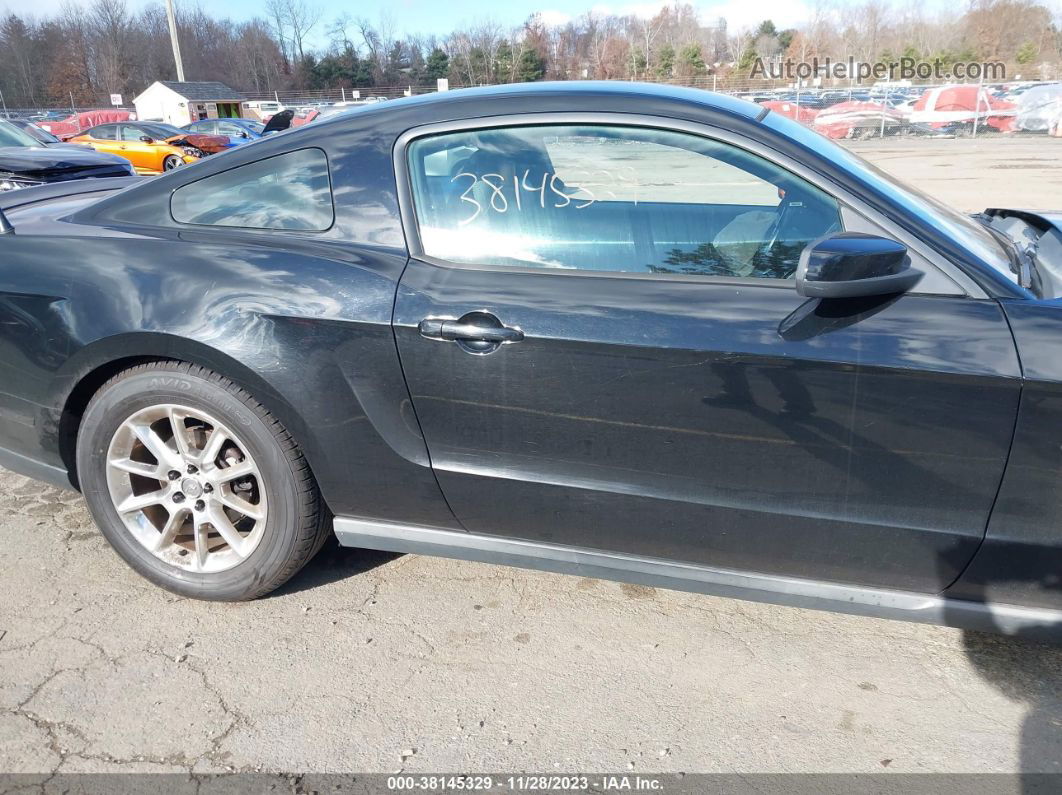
[394, 124, 1018, 591]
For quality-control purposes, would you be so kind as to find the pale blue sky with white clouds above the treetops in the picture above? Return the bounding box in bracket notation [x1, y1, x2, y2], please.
[8, 0, 828, 46]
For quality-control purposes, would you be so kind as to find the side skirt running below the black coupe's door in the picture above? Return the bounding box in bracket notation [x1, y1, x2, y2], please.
[335, 517, 1062, 640]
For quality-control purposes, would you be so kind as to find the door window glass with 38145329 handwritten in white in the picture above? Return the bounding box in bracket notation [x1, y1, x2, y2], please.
[409, 125, 842, 279]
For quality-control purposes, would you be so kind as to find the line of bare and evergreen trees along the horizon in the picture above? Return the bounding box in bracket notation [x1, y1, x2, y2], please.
[0, 0, 1062, 107]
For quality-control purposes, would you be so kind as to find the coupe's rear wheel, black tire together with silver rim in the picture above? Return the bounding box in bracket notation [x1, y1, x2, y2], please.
[76, 361, 329, 601]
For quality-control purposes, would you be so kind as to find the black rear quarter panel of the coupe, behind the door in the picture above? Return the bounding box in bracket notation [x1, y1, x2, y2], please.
[0, 148, 458, 528]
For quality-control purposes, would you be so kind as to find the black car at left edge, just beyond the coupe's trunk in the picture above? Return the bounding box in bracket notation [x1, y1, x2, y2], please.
[0, 120, 134, 191]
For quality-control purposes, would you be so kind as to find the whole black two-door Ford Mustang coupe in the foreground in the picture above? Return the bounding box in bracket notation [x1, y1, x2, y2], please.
[0, 83, 1062, 635]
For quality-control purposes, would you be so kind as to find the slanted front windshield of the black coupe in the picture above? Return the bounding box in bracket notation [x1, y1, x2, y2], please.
[763, 114, 1017, 284]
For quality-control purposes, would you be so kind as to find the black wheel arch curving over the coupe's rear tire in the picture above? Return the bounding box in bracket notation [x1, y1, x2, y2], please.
[54, 332, 316, 487]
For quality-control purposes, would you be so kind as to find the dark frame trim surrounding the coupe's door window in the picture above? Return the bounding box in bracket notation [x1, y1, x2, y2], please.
[392, 111, 988, 298]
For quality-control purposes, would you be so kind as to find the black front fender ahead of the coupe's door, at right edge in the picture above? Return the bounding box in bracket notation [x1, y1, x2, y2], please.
[948, 299, 1062, 608]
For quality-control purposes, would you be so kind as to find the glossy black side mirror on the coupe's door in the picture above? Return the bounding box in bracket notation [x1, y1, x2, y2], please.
[797, 231, 922, 298]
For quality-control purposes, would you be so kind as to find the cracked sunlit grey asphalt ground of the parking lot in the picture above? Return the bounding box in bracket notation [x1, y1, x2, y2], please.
[0, 136, 1062, 775]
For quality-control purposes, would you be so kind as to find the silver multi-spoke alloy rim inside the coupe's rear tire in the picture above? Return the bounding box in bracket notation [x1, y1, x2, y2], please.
[106, 404, 268, 573]
